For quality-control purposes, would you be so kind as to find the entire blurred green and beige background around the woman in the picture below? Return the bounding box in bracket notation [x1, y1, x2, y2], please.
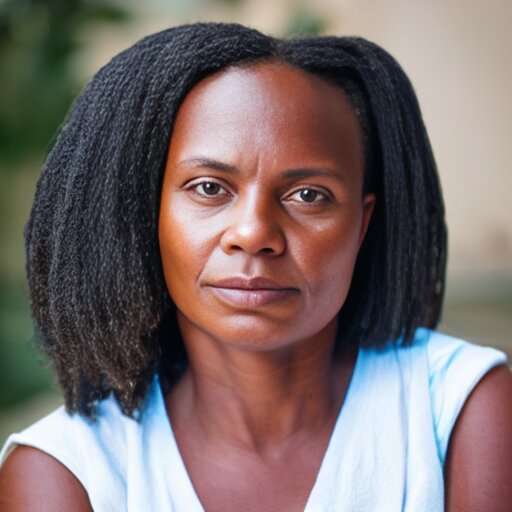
[0, 0, 512, 443]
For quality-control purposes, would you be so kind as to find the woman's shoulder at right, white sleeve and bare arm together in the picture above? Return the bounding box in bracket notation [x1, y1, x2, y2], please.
[412, 329, 512, 512]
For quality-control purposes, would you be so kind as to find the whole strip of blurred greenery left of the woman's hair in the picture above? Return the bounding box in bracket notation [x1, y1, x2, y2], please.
[0, 0, 129, 412]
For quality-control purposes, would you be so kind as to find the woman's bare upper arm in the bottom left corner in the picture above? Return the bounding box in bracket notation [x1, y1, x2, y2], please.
[0, 446, 92, 512]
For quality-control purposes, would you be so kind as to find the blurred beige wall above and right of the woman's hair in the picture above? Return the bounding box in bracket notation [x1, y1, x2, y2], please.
[77, 0, 512, 297]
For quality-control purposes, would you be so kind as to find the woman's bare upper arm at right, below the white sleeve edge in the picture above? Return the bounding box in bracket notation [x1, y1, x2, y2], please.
[445, 365, 512, 512]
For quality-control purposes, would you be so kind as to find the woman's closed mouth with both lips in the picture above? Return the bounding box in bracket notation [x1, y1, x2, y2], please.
[208, 277, 299, 307]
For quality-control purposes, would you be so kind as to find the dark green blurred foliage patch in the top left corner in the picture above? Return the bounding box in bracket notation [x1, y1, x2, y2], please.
[0, 0, 128, 164]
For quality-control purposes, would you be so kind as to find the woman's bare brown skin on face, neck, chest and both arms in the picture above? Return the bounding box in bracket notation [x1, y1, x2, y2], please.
[0, 63, 512, 512]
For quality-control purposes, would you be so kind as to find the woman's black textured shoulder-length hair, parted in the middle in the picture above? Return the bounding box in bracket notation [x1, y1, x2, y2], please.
[25, 24, 446, 417]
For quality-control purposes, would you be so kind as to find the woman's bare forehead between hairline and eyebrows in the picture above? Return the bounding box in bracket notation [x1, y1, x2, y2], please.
[166, 61, 362, 174]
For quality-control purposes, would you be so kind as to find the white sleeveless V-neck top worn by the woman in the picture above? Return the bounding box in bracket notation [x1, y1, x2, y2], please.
[0, 329, 506, 512]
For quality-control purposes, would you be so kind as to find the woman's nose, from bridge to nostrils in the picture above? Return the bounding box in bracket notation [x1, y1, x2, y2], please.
[220, 194, 286, 256]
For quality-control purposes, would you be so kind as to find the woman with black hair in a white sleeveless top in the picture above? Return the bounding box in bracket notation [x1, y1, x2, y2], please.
[0, 24, 512, 511]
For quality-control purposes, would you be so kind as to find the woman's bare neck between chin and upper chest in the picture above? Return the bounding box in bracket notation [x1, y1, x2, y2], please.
[168, 318, 355, 452]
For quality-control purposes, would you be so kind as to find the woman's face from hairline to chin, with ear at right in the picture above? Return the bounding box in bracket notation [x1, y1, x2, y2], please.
[159, 62, 375, 350]
